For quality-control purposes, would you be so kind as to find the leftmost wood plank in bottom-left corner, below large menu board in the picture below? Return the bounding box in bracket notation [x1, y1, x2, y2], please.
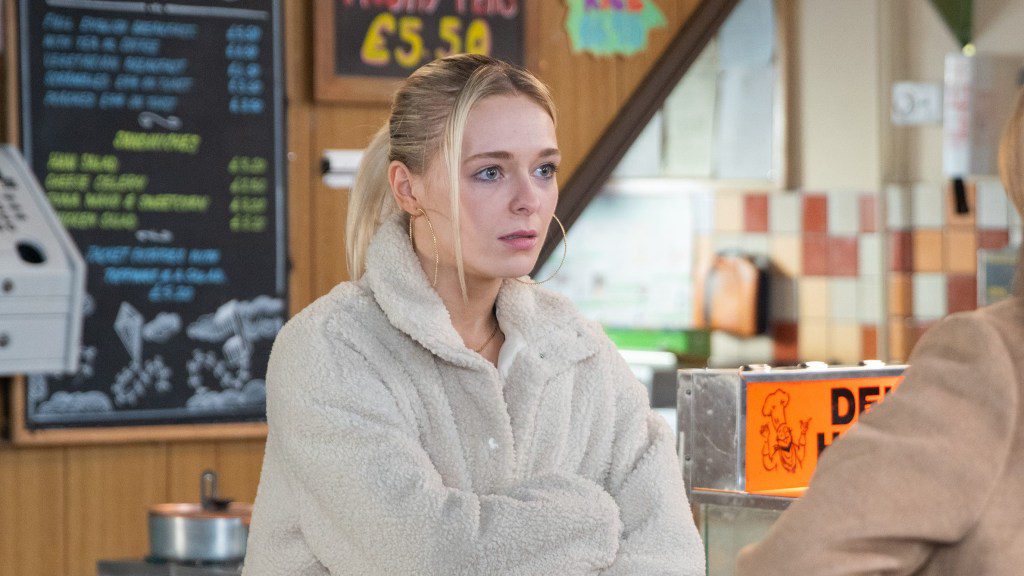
[0, 447, 67, 575]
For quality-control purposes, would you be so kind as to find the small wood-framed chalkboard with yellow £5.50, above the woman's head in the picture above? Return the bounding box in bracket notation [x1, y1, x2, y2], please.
[316, 0, 523, 101]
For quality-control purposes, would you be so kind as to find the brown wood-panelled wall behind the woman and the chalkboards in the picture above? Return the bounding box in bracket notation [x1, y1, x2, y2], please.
[0, 0, 716, 576]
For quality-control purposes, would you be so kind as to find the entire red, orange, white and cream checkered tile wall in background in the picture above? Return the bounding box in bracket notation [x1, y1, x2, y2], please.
[695, 180, 1020, 367]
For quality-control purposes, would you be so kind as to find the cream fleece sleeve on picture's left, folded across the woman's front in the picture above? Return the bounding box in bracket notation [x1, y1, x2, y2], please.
[260, 315, 622, 575]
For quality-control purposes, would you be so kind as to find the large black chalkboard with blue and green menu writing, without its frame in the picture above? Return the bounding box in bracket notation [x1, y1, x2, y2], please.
[18, 0, 288, 429]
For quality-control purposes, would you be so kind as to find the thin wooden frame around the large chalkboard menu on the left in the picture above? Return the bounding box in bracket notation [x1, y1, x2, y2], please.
[9, 0, 289, 445]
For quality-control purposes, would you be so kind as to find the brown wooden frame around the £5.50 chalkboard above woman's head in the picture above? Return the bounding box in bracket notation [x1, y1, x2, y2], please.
[313, 0, 535, 104]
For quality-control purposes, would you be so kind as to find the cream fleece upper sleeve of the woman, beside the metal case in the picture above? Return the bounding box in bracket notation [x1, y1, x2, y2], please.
[601, 351, 705, 576]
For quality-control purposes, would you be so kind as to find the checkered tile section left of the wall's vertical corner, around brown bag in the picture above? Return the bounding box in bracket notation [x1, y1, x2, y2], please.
[697, 191, 884, 367]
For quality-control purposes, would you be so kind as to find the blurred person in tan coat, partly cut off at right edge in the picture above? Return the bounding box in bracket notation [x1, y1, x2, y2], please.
[736, 91, 1024, 576]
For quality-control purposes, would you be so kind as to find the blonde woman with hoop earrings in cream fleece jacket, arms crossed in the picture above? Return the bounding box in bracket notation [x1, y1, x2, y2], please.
[244, 55, 703, 576]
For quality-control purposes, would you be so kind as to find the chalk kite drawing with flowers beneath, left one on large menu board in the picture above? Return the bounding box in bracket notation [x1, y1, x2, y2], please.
[111, 302, 173, 406]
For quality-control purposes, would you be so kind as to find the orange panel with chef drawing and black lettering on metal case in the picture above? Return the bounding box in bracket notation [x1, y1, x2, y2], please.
[745, 376, 903, 496]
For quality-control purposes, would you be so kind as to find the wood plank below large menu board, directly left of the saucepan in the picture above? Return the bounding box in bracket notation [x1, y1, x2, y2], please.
[63, 444, 167, 576]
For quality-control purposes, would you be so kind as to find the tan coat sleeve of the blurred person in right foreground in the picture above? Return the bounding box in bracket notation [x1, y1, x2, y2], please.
[736, 314, 1020, 576]
